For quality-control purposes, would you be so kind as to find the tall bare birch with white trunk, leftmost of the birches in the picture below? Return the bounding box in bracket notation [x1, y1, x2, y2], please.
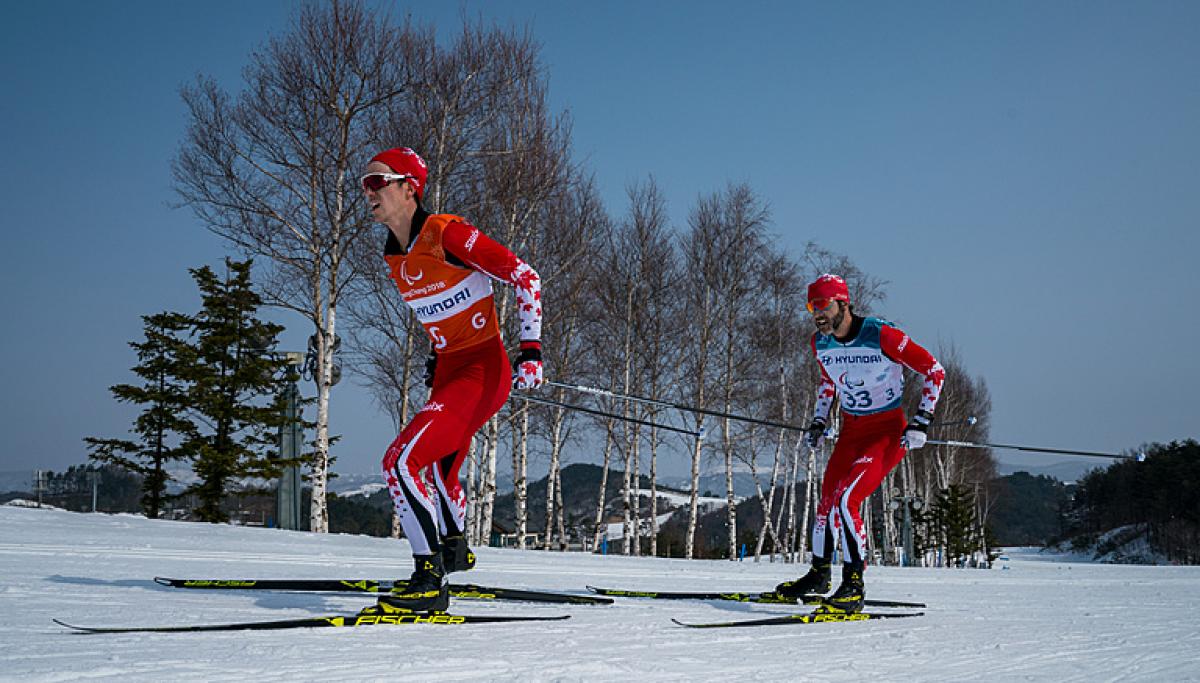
[173, 1, 407, 532]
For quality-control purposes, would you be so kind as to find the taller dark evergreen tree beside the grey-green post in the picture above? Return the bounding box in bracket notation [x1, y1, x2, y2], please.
[178, 259, 287, 522]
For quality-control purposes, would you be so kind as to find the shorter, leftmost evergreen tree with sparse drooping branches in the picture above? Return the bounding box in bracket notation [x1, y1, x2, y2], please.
[84, 312, 196, 519]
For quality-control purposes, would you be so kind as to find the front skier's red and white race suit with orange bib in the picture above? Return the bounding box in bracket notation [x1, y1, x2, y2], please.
[383, 210, 541, 555]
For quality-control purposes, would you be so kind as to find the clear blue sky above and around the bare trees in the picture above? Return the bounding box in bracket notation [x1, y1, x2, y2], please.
[0, 0, 1200, 480]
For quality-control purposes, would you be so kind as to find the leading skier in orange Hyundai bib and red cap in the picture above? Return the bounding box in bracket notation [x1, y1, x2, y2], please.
[361, 148, 542, 612]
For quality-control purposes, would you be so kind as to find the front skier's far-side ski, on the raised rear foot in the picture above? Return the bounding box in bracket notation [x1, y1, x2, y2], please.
[155, 576, 612, 605]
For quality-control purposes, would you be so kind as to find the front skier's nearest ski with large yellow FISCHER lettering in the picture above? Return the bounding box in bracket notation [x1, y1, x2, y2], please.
[54, 613, 570, 634]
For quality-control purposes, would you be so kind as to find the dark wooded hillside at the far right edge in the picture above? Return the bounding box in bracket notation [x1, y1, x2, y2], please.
[1066, 439, 1200, 564]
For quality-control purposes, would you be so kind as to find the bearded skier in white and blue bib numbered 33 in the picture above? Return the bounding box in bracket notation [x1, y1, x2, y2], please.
[775, 274, 946, 612]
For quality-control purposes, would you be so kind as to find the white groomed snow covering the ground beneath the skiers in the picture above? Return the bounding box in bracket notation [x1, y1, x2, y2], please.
[0, 507, 1200, 682]
